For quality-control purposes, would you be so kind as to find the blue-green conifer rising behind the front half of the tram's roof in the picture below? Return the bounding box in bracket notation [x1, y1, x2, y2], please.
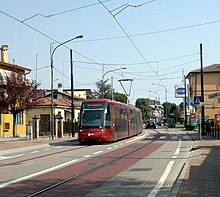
[92, 79, 112, 99]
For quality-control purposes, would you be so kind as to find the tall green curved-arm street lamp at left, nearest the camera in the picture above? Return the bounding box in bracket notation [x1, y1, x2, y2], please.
[50, 35, 83, 140]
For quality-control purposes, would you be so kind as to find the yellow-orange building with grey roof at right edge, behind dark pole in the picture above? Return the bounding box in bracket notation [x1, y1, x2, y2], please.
[186, 64, 220, 119]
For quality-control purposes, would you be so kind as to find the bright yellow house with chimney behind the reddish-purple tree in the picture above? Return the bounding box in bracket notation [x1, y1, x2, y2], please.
[0, 45, 31, 137]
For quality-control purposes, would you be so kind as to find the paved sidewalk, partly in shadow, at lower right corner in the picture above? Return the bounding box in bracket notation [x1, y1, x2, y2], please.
[177, 132, 220, 197]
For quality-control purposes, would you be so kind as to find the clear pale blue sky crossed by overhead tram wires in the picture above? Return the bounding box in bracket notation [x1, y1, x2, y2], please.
[0, 0, 220, 104]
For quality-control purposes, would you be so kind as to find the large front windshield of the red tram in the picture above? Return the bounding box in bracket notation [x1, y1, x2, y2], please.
[79, 102, 111, 128]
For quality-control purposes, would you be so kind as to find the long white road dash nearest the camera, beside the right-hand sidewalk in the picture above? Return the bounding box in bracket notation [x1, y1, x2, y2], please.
[148, 161, 174, 197]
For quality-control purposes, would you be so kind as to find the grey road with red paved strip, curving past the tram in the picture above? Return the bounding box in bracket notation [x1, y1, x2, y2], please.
[0, 129, 193, 197]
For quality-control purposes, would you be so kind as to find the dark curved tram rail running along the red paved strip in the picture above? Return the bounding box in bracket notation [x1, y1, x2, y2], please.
[26, 130, 161, 197]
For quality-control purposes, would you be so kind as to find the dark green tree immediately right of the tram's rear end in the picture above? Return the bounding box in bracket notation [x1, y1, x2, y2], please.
[135, 98, 150, 121]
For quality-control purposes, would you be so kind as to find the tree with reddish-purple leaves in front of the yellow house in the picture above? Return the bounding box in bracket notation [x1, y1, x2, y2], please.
[0, 72, 45, 137]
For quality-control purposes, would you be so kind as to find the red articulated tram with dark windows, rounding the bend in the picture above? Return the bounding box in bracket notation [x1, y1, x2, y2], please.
[78, 99, 143, 143]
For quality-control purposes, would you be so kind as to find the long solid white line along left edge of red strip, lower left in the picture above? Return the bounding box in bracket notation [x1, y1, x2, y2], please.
[0, 159, 78, 188]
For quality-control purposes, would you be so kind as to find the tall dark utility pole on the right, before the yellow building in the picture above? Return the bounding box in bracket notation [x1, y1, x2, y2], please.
[200, 43, 205, 135]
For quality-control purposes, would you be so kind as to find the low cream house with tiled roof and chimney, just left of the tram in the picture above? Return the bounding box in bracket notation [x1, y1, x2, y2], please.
[27, 87, 86, 138]
